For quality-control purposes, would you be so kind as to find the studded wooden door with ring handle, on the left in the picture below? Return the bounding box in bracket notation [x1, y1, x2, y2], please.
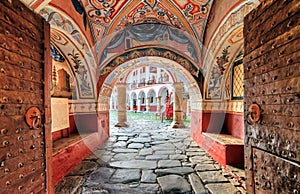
[0, 0, 52, 193]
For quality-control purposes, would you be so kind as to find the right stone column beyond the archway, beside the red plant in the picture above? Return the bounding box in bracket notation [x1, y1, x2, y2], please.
[171, 83, 185, 128]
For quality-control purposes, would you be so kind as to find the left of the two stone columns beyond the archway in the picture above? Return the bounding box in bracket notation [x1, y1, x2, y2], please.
[115, 83, 128, 127]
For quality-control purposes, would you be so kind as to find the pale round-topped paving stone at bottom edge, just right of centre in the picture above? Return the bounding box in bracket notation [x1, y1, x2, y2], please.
[157, 175, 191, 193]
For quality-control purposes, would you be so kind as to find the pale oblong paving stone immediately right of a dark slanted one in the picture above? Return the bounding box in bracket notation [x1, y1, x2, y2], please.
[110, 169, 141, 183]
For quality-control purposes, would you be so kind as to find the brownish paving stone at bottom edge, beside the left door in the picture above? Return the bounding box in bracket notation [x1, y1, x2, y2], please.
[54, 176, 83, 194]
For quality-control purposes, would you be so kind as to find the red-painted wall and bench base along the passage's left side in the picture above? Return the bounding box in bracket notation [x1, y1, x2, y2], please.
[52, 111, 109, 185]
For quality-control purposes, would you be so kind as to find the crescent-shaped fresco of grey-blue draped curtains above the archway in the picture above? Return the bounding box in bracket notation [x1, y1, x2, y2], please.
[99, 24, 199, 66]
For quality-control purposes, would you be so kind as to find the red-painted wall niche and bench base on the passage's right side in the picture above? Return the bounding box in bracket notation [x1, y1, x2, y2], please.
[191, 111, 244, 166]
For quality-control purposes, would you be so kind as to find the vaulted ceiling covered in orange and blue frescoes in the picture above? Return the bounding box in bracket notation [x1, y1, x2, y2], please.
[22, 0, 263, 98]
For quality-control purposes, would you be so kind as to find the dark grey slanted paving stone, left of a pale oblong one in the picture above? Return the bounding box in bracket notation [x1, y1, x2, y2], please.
[87, 167, 116, 184]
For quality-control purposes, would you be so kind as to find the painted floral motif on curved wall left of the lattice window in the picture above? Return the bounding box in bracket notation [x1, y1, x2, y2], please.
[208, 46, 230, 99]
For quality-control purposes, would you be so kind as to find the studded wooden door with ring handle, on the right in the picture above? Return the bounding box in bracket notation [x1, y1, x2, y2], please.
[244, 0, 300, 194]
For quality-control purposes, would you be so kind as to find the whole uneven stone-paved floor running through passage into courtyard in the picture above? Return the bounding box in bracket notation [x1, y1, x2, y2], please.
[55, 116, 245, 194]
